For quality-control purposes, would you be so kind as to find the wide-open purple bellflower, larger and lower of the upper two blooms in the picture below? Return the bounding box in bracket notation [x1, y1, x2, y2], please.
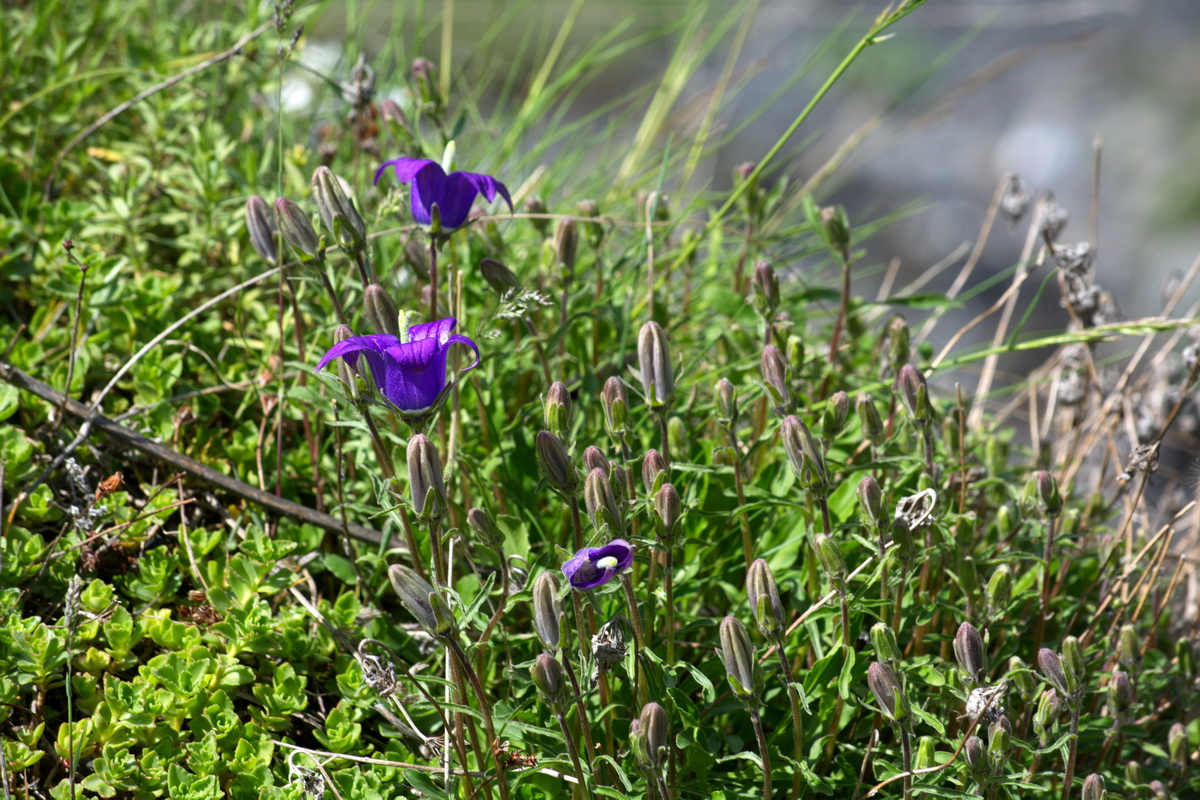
[317, 317, 479, 414]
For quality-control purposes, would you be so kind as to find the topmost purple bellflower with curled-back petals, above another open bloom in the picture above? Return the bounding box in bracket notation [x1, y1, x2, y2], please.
[374, 158, 512, 233]
